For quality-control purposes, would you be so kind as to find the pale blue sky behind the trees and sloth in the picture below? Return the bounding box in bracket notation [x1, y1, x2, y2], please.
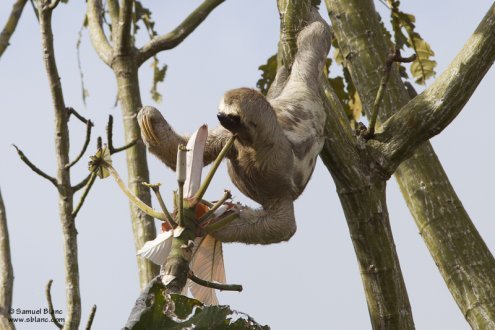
[0, 0, 495, 330]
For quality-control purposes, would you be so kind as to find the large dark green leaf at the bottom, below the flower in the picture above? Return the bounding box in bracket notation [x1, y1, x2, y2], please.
[124, 277, 269, 330]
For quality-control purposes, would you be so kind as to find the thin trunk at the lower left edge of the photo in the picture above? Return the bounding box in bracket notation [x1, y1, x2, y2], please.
[0, 187, 15, 330]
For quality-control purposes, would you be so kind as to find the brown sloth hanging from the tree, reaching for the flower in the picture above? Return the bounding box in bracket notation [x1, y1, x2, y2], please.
[138, 10, 331, 244]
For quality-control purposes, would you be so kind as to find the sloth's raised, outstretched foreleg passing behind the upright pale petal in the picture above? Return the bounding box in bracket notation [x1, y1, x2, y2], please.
[137, 106, 232, 171]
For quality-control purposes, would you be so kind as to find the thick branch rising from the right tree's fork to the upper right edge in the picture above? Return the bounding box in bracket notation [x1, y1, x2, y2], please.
[368, 4, 495, 174]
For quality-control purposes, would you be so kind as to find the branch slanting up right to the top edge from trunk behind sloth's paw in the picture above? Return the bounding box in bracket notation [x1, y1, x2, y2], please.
[137, 0, 225, 66]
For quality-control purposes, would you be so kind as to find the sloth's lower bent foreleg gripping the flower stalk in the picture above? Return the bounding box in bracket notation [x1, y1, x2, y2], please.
[210, 200, 296, 244]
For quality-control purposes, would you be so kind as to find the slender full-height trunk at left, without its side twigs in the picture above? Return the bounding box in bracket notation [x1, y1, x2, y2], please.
[39, 5, 81, 329]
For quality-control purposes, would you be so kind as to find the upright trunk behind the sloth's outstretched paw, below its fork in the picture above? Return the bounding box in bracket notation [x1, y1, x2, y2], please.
[112, 56, 159, 288]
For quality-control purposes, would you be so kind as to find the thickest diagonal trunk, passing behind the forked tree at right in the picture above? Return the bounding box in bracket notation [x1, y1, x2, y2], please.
[326, 0, 495, 329]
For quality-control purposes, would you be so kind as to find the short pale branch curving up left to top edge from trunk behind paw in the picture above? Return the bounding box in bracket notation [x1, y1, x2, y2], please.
[87, 0, 113, 66]
